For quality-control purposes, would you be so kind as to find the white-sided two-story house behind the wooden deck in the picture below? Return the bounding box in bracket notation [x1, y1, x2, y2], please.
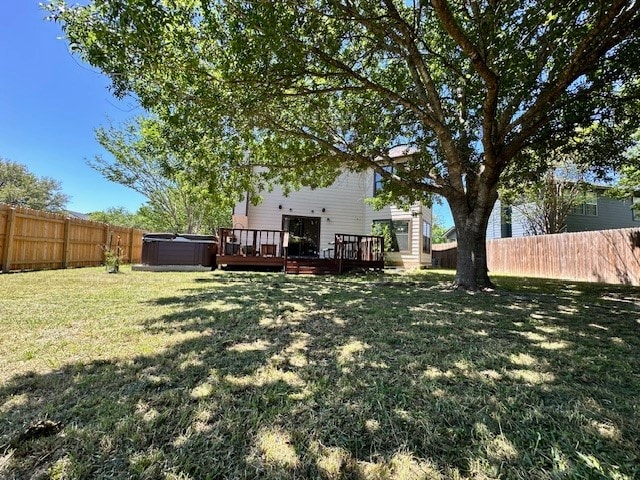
[233, 147, 432, 267]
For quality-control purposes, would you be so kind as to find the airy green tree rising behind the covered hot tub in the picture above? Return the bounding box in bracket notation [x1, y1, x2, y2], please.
[89, 117, 232, 233]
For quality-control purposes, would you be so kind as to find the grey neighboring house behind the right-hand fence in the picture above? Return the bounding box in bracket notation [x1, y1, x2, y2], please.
[487, 187, 640, 239]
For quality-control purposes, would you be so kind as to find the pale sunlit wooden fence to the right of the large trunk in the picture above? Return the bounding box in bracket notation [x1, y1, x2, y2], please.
[433, 228, 640, 285]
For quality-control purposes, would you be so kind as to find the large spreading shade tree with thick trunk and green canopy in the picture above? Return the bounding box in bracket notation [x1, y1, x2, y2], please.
[49, 0, 640, 288]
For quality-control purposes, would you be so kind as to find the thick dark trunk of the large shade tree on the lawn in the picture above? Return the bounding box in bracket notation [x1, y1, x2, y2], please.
[449, 189, 497, 290]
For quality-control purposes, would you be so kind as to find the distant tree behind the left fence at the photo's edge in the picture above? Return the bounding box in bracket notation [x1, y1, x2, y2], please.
[0, 158, 69, 212]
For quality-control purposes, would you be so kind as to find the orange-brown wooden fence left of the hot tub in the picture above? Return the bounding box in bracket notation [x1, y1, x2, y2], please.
[0, 204, 143, 273]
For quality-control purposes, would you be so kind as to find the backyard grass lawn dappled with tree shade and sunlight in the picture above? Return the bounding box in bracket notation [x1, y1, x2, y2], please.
[0, 269, 640, 480]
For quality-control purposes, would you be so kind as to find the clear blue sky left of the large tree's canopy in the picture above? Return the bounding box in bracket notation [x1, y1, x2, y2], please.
[0, 0, 453, 227]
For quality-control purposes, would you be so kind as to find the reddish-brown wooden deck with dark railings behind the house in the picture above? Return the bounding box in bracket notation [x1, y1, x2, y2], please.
[216, 228, 384, 274]
